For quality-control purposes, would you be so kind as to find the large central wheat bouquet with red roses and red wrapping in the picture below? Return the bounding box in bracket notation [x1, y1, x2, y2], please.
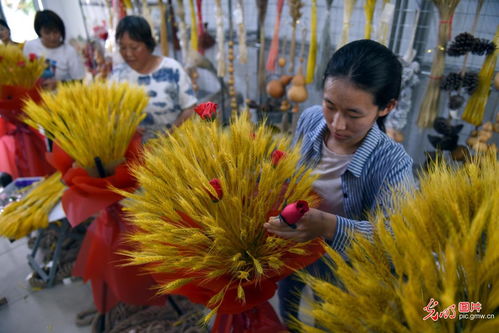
[120, 105, 323, 320]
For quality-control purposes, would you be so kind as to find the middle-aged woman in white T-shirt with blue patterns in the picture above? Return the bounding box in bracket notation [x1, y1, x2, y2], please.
[110, 16, 197, 137]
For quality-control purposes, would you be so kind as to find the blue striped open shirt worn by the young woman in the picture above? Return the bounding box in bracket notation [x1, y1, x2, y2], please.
[293, 105, 414, 254]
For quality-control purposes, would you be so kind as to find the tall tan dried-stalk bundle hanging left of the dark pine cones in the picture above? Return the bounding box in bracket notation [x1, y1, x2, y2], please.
[418, 0, 460, 127]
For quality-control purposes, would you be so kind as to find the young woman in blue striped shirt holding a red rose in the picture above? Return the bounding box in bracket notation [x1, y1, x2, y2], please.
[265, 40, 413, 330]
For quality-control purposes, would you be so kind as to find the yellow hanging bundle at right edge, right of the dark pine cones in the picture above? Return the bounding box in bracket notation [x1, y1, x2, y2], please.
[462, 25, 499, 126]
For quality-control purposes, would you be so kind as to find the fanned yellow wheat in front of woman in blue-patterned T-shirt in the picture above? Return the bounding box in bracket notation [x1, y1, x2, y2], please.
[24, 82, 148, 168]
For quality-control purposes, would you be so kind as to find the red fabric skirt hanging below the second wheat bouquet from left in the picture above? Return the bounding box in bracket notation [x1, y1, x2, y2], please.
[73, 203, 166, 313]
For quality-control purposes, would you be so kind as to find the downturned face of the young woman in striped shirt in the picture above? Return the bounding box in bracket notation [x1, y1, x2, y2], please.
[322, 77, 395, 154]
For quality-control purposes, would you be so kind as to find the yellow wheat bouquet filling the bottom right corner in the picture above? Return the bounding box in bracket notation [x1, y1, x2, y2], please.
[297, 154, 499, 333]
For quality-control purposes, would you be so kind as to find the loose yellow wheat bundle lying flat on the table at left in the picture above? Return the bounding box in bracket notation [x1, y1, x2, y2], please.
[0, 172, 65, 239]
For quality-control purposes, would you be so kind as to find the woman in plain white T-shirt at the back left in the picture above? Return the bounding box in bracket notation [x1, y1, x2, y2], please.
[23, 9, 85, 90]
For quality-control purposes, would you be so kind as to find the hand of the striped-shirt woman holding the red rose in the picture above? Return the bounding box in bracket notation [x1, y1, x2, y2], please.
[263, 208, 336, 242]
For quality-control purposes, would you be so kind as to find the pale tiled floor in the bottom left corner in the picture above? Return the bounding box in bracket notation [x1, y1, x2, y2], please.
[0, 238, 92, 333]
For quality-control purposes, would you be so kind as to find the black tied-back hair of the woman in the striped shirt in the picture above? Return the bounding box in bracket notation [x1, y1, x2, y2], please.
[323, 39, 402, 132]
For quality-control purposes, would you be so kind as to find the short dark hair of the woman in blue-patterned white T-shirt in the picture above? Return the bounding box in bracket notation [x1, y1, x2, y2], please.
[115, 15, 156, 52]
